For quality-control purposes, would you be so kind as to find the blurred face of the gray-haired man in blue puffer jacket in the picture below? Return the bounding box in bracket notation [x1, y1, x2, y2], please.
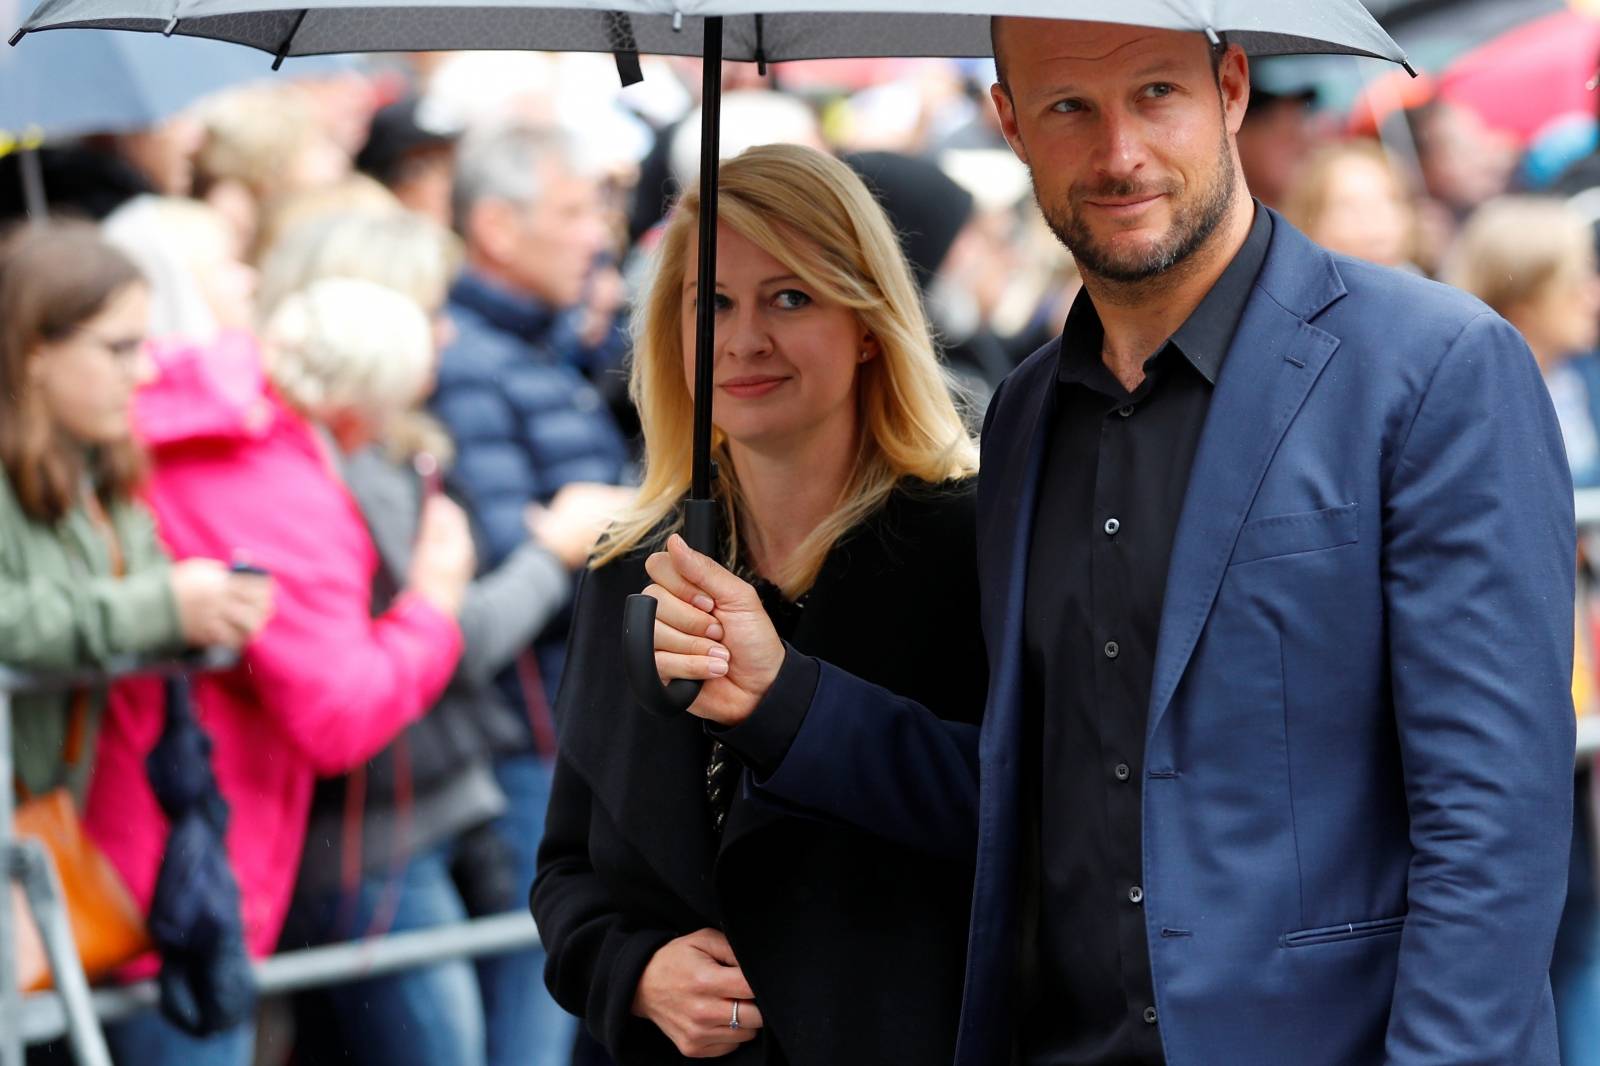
[472, 165, 610, 307]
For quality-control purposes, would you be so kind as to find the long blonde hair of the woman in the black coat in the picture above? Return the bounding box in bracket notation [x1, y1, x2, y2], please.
[590, 144, 978, 599]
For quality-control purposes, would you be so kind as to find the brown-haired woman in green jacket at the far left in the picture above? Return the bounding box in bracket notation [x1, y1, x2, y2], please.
[0, 222, 272, 802]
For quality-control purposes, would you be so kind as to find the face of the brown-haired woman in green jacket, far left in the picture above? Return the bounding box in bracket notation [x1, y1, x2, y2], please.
[29, 283, 154, 445]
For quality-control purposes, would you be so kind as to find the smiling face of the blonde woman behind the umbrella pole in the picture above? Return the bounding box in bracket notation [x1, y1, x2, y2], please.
[683, 226, 877, 450]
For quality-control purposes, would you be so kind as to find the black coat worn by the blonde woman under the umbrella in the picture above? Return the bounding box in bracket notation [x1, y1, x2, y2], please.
[533, 482, 987, 1066]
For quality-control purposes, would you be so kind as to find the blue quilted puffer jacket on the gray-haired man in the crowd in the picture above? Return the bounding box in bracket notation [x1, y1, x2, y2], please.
[430, 272, 629, 567]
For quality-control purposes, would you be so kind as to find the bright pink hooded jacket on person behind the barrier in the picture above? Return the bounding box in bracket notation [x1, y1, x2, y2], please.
[85, 335, 461, 973]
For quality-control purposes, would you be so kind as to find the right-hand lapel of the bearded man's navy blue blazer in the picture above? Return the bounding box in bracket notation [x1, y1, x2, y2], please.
[1146, 218, 1344, 738]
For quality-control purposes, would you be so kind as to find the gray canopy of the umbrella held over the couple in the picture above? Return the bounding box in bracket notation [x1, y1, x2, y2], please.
[21, 0, 1405, 62]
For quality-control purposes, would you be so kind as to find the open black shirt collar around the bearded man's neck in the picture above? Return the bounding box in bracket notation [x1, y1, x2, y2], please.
[1058, 202, 1272, 386]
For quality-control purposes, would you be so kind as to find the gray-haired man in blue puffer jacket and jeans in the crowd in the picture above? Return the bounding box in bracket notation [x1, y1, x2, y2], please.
[430, 126, 629, 1066]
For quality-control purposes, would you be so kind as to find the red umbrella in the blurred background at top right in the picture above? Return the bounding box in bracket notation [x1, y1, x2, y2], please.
[1438, 11, 1600, 142]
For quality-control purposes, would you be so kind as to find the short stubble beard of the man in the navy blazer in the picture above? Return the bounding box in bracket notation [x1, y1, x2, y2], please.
[1034, 125, 1238, 288]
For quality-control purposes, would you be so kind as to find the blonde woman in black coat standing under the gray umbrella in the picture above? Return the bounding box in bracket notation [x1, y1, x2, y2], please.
[531, 146, 986, 1066]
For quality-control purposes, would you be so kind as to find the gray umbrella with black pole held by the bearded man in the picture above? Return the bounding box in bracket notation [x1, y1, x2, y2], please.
[11, 0, 1410, 714]
